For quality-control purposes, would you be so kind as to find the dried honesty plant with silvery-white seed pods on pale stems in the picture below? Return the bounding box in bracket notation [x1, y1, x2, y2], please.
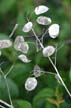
[0, 5, 71, 108]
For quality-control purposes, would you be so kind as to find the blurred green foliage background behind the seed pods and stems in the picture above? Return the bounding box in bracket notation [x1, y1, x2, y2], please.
[0, 0, 71, 108]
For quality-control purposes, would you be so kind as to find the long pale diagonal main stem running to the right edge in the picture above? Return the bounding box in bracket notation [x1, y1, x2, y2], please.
[32, 29, 71, 98]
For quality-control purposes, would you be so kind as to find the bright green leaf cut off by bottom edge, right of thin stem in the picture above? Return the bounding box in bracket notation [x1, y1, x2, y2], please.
[13, 100, 32, 108]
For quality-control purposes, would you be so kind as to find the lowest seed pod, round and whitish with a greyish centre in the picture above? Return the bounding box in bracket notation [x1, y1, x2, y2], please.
[25, 77, 37, 91]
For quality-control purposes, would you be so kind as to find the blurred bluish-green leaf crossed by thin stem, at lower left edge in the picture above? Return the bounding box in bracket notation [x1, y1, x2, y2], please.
[0, 75, 19, 101]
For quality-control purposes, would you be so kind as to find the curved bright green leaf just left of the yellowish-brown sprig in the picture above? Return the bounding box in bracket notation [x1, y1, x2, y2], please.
[33, 88, 54, 108]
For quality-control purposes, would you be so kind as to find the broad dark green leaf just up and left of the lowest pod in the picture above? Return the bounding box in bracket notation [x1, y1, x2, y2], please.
[9, 63, 32, 85]
